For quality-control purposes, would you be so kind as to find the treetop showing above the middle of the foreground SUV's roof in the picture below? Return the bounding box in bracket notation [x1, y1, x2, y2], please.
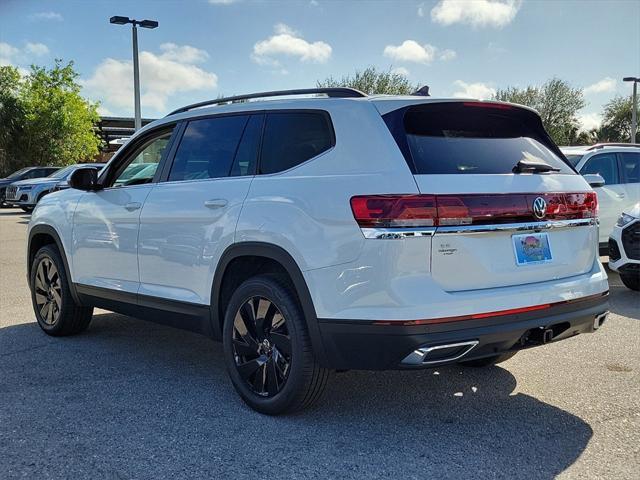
[316, 67, 419, 95]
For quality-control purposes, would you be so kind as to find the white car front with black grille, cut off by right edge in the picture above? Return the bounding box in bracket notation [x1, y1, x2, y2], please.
[609, 203, 640, 290]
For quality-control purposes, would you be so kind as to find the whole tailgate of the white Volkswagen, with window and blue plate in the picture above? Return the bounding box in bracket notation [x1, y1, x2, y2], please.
[385, 102, 597, 292]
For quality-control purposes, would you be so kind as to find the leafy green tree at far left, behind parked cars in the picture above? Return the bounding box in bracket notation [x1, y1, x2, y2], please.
[0, 60, 101, 174]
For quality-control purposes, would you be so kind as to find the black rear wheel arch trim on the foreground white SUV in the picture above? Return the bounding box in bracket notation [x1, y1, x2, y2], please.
[211, 242, 326, 364]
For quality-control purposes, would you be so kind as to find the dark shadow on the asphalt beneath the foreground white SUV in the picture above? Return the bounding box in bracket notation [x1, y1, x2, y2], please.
[0, 314, 593, 479]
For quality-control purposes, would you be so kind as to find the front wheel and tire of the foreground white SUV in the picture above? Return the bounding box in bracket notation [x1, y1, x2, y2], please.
[29, 245, 93, 337]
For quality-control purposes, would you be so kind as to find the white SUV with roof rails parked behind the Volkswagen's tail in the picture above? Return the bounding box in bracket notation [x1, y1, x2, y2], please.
[560, 143, 640, 249]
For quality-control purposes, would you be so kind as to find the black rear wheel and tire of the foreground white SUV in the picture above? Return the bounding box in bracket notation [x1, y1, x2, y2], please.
[223, 275, 330, 415]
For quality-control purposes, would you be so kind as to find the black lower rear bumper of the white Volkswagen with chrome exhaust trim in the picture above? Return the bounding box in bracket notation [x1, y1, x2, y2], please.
[319, 292, 609, 370]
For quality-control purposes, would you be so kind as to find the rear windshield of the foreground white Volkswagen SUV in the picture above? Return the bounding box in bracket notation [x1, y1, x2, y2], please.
[385, 102, 575, 174]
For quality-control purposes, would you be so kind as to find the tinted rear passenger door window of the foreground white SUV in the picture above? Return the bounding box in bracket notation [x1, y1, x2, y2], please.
[169, 115, 248, 181]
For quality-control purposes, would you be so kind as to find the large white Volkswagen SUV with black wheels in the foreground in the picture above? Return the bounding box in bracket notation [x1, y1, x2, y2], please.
[27, 88, 608, 414]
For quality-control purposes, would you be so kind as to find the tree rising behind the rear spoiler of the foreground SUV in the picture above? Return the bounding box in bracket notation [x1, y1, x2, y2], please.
[495, 78, 585, 145]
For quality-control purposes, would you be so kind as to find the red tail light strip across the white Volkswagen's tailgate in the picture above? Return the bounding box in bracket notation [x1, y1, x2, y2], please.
[351, 192, 598, 228]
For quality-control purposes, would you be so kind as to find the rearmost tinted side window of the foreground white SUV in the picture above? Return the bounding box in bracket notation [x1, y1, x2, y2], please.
[260, 112, 333, 173]
